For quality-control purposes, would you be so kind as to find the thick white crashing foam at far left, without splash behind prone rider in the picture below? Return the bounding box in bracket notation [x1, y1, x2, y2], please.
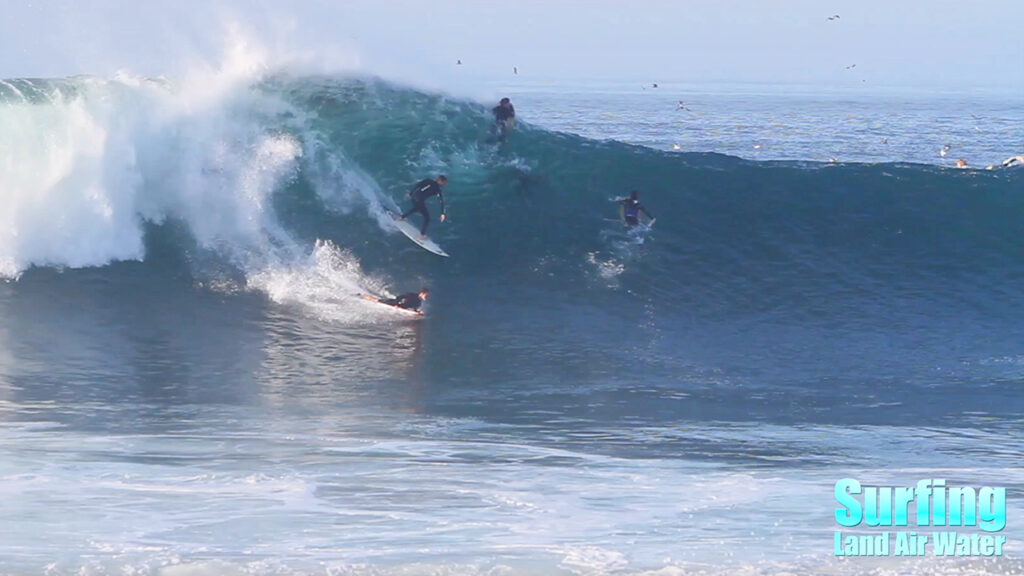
[0, 33, 301, 278]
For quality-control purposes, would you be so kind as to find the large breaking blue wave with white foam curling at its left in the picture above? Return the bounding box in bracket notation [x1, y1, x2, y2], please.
[0, 75, 1024, 334]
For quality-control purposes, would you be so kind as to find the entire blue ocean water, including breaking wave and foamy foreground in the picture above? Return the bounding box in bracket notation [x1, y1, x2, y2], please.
[0, 75, 1024, 576]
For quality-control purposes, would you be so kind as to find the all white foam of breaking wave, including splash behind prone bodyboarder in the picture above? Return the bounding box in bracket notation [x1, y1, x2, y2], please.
[0, 27, 405, 325]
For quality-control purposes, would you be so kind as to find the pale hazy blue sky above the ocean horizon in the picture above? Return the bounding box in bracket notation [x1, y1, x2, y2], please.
[0, 0, 1024, 92]
